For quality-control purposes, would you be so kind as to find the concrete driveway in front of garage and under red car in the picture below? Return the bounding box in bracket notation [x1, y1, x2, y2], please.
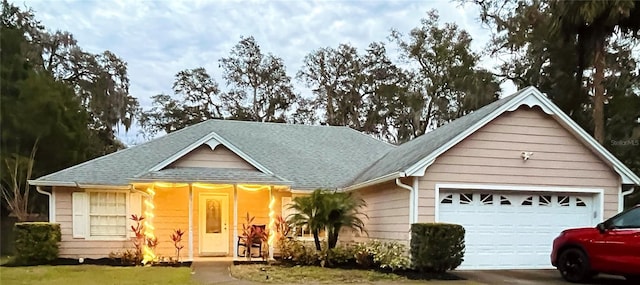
[453, 270, 632, 285]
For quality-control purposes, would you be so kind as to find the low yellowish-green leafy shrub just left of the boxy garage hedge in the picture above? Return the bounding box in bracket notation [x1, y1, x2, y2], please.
[354, 240, 410, 271]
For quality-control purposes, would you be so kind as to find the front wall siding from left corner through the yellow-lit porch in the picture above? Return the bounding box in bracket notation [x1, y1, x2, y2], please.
[54, 186, 291, 259]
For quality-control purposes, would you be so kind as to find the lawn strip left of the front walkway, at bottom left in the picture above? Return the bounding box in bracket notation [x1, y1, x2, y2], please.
[0, 265, 197, 285]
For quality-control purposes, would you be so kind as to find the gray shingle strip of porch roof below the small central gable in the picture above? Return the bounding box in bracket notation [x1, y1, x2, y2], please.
[132, 167, 291, 184]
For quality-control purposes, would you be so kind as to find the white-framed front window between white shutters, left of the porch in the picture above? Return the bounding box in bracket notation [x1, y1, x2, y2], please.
[89, 192, 127, 238]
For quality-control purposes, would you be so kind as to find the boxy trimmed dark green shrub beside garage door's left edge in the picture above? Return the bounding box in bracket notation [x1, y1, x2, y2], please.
[411, 223, 465, 273]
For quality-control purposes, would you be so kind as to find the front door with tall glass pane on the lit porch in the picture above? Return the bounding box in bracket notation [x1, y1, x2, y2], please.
[199, 194, 229, 255]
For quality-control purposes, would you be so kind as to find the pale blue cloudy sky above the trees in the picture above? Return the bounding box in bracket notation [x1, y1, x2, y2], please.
[13, 0, 515, 145]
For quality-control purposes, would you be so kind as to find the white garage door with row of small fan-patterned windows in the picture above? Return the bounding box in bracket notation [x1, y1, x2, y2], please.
[438, 190, 596, 269]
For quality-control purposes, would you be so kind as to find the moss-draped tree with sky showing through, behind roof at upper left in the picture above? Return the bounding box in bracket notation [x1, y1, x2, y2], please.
[2, 0, 139, 152]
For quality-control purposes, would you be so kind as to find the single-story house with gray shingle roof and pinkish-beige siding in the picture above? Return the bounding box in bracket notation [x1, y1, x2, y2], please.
[30, 87, 640, 269]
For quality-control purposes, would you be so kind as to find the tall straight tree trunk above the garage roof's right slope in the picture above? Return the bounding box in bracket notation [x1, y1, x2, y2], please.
[593, 40, 605, 144]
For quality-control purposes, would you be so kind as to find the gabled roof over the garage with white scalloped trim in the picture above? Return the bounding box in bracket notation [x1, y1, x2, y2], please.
[346, 87, 640, 189]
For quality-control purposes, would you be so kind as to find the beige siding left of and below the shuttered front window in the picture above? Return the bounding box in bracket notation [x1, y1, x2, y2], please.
[53, 187, 133, 258]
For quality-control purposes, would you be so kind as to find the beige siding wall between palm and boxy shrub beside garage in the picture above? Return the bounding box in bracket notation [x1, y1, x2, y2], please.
[348, 179, 411, 242]
